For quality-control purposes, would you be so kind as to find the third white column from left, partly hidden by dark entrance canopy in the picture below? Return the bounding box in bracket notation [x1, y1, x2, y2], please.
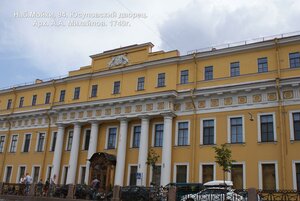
[84, 121, 99, 185]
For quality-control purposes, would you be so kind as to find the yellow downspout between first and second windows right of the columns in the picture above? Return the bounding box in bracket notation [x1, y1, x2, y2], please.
[190, 53, 198, 182]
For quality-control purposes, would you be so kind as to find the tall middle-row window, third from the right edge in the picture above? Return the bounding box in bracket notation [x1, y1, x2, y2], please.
[230, 117, 243, 144]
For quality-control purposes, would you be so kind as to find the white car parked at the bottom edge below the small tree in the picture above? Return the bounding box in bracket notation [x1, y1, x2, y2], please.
[180, 180, 245, 201]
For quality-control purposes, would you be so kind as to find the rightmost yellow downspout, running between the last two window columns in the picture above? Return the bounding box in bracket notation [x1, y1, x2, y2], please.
[275, 38, 287, 189]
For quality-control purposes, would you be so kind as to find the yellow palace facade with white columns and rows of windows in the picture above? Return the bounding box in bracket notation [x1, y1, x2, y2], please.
[0, 36, 300, 189]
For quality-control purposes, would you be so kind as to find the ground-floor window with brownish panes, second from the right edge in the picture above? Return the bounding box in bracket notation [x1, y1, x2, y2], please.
[262, 164, 276, 190]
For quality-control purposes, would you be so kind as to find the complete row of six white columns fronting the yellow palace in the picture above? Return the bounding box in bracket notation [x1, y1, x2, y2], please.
[51, 113, 174, 186]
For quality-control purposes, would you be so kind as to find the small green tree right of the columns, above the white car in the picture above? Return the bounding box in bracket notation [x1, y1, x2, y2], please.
[213, 143, 235, 184]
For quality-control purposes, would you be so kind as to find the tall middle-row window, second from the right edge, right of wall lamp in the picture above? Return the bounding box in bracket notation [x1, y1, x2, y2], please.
[260, 115, 274, 142]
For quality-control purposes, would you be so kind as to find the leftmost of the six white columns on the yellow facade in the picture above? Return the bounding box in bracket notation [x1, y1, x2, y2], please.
[51, 124, 65, 184]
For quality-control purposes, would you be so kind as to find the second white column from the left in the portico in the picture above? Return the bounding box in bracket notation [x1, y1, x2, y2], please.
[67, 123, 81, 184]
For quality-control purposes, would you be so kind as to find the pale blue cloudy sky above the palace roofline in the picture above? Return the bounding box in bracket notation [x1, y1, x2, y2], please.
[0, 0, 300, 88]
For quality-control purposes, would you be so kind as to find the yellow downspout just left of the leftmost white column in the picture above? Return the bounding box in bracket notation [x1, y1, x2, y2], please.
[41, 80, 56, 181]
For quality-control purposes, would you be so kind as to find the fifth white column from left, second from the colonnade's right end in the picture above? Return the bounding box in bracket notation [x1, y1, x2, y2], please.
[137, 116, 149, 186]
